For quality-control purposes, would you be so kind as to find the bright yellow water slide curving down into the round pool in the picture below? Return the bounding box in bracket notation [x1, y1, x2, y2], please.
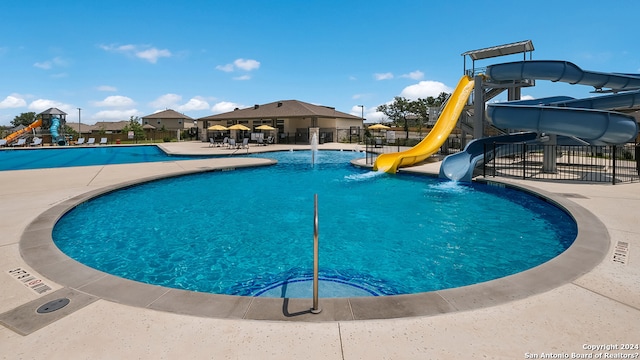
[373, 75, 474, 174]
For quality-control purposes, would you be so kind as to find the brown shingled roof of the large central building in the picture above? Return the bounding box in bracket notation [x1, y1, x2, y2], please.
[200, 100, 360, 120]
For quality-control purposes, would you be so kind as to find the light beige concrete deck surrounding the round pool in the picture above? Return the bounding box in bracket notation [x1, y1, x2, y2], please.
[0, 142, 640, 359]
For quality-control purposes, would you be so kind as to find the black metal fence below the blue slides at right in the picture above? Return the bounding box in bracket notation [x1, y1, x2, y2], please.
[482, 143, 640, 184]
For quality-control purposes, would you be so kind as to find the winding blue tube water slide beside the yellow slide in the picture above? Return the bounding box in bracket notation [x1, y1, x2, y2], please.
[440, 60, 640, 181]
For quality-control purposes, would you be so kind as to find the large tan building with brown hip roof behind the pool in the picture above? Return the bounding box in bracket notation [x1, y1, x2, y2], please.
[198, 100, 364, 143]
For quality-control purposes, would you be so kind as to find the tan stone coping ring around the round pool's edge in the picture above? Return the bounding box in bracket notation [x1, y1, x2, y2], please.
[19, 159, 610, 322]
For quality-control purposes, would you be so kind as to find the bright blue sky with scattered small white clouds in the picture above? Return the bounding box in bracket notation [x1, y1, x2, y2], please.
[0, 0, 640, 125]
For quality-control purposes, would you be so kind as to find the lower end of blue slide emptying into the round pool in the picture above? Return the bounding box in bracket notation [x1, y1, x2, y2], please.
[439, 132, 537, 182]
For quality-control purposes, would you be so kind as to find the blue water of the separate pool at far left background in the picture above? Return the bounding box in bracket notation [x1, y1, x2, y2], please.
[0, 145, 216, 171]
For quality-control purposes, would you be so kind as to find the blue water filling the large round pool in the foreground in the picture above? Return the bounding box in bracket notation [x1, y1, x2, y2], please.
[53, 151, 577, 297]
